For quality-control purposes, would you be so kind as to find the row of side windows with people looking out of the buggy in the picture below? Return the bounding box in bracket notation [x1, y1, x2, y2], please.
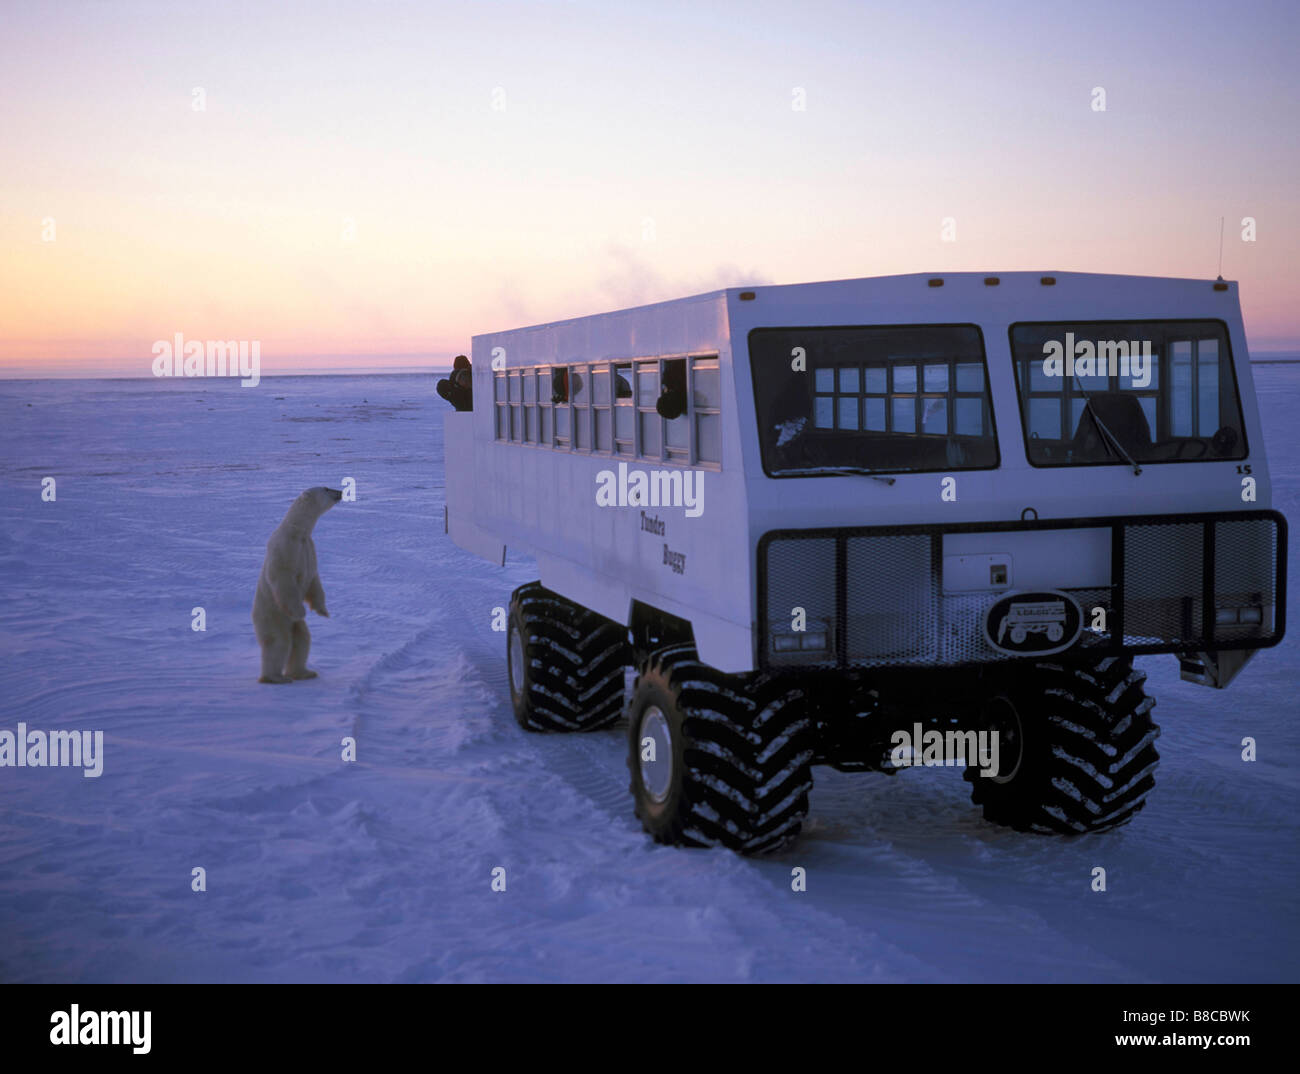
[493, 355, 723, 468]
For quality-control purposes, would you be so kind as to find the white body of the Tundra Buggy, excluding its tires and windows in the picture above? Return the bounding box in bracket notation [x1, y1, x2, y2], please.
[446, 272, 1284, 672]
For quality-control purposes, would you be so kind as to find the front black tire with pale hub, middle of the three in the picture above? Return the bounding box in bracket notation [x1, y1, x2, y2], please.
[628, 645, 814, 854]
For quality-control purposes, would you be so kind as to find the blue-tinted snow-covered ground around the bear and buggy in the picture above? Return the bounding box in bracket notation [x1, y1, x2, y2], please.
[0, 365, 1300, 980]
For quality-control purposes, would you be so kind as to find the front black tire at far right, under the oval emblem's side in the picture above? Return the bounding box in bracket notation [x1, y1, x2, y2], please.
[966, 657, 1160, 835]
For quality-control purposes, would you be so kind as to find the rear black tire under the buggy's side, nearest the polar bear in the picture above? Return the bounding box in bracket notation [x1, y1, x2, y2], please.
[506, 581, 631, 731]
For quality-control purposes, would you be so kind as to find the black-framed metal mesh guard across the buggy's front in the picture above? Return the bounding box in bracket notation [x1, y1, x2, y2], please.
[759, 512, 1286, 667]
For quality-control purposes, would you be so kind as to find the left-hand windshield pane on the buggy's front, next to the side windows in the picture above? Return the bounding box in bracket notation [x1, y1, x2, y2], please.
[749, 325, 997, 477]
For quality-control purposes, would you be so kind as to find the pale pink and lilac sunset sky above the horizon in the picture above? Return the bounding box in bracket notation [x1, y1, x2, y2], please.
[0, 0, 1300, 376]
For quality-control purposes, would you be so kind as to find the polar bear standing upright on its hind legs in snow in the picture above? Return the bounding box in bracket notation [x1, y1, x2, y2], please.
[252, 488, 343, 683]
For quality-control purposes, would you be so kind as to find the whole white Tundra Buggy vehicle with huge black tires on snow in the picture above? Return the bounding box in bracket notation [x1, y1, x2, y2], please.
[446, 272, 1286, 853]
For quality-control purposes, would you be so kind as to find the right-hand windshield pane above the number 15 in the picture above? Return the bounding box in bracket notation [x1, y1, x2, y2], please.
[1011, 321, 1245, 465]
